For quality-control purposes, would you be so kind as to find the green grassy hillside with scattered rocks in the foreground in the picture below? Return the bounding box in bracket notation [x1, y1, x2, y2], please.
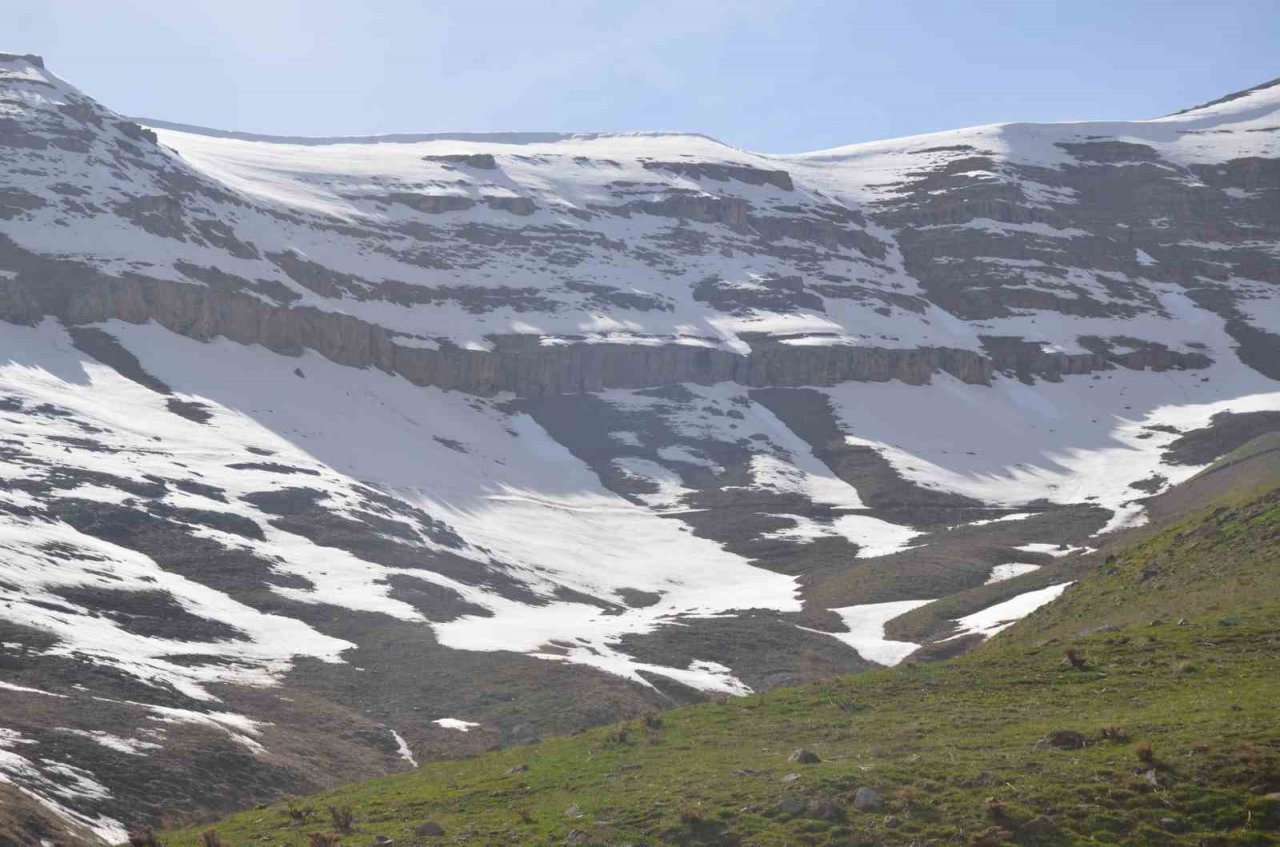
[168, 490, 1280, 847]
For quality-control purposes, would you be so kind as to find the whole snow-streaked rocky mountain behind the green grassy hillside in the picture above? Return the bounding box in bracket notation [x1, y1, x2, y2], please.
[0, 54, 1280, 843]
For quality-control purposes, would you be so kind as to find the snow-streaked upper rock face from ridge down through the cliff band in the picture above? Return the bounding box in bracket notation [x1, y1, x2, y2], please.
[0, 56, 1280, 397]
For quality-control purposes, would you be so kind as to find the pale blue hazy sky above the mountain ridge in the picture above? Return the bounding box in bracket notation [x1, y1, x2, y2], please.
[0, 0, 1280, 152]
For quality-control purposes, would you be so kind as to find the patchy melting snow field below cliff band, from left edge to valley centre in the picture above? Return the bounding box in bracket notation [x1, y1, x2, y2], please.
[0, 324, 798, 699]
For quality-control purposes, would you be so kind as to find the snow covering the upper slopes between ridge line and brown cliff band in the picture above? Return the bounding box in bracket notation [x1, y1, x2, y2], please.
[0, 51, 1280, 378]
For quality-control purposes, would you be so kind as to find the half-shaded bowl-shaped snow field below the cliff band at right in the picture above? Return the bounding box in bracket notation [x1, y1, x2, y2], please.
[823, 312, 1280, 534]
